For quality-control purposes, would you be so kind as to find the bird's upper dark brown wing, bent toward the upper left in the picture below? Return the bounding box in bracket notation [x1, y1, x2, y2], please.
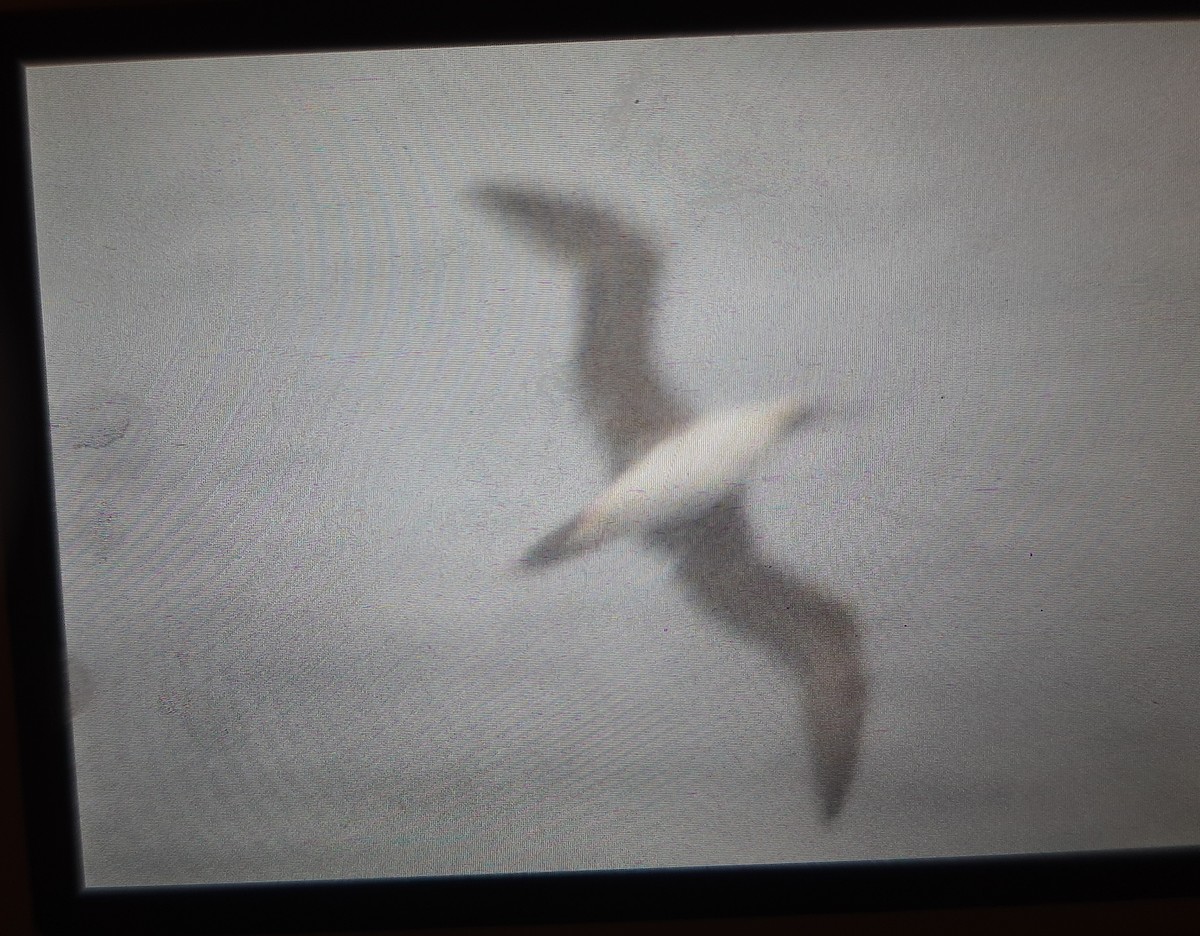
[472, 184, 692, 476]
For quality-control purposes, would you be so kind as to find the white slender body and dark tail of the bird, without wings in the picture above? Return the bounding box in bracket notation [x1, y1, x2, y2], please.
[523, 398, 805, 565]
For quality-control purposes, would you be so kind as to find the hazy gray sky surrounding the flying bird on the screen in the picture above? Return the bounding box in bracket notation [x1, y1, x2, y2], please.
[29, 24, 1200, 884]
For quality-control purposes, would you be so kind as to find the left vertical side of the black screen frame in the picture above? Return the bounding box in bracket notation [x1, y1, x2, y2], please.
[0, 30, 82, 931]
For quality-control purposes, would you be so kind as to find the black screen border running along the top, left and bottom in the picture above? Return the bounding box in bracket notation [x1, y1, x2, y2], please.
[7, 0, 1200, 934]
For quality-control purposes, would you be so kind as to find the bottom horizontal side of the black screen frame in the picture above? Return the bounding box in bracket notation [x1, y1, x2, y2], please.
[65, 847, 1200, 934]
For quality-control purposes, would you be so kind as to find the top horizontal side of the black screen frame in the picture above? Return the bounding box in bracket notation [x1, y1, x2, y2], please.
[6, 0, 1195, 64]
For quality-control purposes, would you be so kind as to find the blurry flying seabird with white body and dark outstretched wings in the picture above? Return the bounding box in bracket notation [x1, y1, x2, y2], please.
[470, 182, 866, 820]
